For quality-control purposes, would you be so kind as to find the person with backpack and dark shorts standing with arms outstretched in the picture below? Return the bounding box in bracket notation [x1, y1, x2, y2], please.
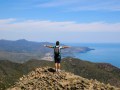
[44, 41, 69, 71]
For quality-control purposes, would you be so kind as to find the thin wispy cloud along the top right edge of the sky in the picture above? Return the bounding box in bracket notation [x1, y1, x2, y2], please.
[37, 0, 120, 11]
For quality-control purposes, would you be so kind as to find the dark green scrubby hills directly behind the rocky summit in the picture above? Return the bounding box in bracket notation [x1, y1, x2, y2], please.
[0, 57, 120, 89]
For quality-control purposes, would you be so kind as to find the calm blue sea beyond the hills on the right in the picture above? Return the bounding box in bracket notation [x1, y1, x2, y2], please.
[67, 43, 120, 68]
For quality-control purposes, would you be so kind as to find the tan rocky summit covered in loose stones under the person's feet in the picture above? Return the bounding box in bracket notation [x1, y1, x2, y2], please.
[7, 67, 120, 90]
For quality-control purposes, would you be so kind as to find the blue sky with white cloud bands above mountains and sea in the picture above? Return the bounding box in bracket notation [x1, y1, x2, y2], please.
[0, 0, 120, 43]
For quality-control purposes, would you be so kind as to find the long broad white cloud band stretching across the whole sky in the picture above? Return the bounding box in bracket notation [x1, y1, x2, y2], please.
[0, 19, 120, 32]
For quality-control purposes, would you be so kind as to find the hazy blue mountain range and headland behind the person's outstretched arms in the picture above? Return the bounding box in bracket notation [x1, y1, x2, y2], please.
[0, 39, 92, 63]
